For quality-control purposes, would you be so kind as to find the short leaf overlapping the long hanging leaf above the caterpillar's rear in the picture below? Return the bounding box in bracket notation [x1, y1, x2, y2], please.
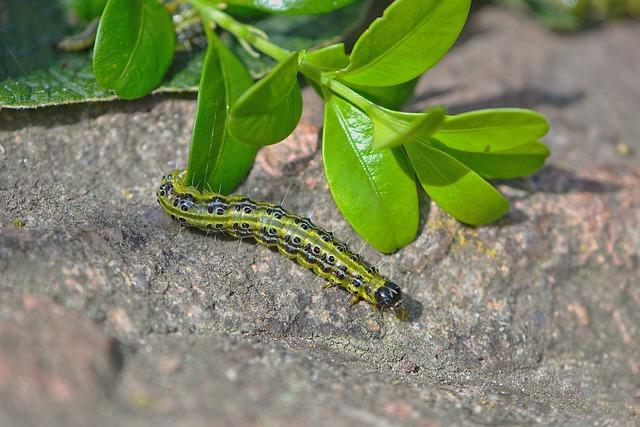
[229, 52, 302, 145]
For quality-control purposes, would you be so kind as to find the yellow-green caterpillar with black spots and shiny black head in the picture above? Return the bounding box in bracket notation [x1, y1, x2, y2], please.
[156, 170, 407, 319]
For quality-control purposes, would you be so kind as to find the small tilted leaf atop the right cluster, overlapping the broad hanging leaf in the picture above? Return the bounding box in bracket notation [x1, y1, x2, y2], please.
[372, 107, 447, 150]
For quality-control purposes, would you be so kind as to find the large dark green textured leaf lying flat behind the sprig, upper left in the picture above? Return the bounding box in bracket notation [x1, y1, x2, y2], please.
[0, 0, 203, 108]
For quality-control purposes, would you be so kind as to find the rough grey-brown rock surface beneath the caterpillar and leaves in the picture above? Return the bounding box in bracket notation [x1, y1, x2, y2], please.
[0, 7, 640, 426]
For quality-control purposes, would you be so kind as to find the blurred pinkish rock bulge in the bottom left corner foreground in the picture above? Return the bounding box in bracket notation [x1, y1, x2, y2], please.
[0, 292, 124, 425]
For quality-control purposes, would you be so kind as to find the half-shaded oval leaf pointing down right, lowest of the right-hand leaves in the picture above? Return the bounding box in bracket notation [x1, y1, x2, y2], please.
[405, 142, 509, 225]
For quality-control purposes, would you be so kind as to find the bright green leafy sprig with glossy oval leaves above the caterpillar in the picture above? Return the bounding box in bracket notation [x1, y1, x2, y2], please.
[93, 0, 549, 253]
